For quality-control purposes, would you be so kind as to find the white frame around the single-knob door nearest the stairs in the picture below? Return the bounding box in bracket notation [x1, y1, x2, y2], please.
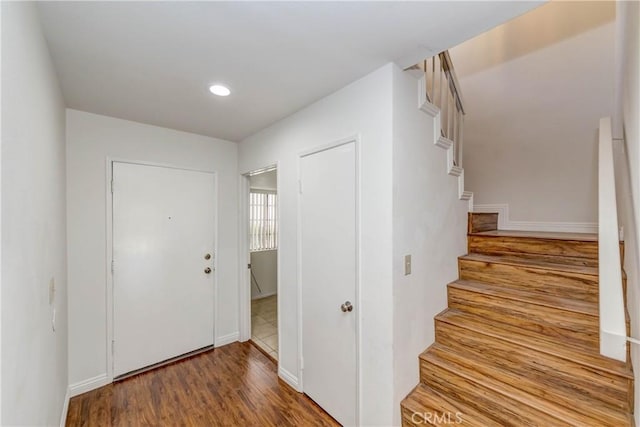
[296, 134, 362, 425]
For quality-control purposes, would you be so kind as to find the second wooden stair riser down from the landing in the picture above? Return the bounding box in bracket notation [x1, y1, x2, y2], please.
[458, 259, 598, 302]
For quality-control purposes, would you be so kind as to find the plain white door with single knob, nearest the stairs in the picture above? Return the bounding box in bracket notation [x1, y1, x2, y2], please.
[300, 142, 358, 426]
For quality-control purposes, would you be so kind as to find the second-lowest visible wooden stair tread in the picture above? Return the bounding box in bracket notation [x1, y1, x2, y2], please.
[420, 343, 630, 425]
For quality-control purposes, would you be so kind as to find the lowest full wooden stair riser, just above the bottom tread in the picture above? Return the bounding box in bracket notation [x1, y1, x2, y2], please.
[420, 360, 569, 426]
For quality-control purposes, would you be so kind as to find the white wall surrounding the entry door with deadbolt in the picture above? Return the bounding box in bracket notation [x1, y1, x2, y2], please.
[67, 110, 238, 389]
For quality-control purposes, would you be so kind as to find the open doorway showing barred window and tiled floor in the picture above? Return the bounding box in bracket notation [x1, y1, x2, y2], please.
[247, 167, 279, 361]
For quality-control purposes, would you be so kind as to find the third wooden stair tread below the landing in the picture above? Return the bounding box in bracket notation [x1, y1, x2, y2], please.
[436, 309, 634, 380]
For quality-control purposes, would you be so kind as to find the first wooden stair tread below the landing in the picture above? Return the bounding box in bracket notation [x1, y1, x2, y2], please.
[459, 252, 598, 276]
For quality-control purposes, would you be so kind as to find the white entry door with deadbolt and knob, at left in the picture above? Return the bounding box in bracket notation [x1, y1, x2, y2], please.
[113, 162, 215, 376]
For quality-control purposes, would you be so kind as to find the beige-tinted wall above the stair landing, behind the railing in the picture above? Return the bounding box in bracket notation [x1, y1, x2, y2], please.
[451, 2, 615, 223]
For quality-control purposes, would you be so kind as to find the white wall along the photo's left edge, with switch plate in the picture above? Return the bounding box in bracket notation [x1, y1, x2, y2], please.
[0, 2, 68, 426]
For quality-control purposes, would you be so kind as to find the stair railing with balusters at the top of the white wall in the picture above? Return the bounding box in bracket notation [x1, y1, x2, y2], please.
[417, 50, 465, 168]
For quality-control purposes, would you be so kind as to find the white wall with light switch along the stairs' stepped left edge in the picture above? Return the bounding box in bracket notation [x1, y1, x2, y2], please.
[393, 67, 469, 425]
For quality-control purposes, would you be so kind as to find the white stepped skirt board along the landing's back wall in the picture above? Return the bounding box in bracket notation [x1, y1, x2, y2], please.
[472, 203, 598, 233]
